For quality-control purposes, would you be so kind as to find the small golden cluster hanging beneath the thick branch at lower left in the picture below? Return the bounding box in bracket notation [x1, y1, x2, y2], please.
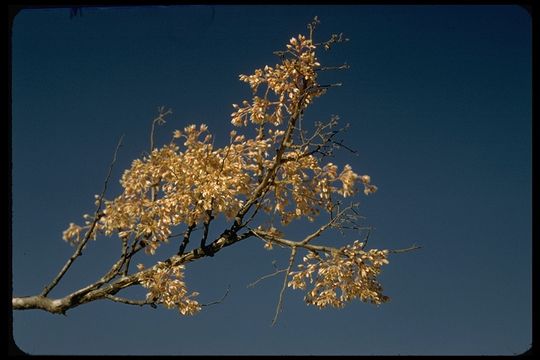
[137, 262, 201, 315]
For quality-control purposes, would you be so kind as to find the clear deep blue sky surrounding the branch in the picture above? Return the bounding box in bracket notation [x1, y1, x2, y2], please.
[12, 5, 532, 355]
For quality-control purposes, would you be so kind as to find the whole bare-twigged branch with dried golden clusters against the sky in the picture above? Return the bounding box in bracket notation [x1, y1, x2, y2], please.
[14, 18, 418, 322]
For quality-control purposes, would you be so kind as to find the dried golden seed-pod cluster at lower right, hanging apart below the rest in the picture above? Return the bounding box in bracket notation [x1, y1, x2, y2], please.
[288, 241, 389, 308]
